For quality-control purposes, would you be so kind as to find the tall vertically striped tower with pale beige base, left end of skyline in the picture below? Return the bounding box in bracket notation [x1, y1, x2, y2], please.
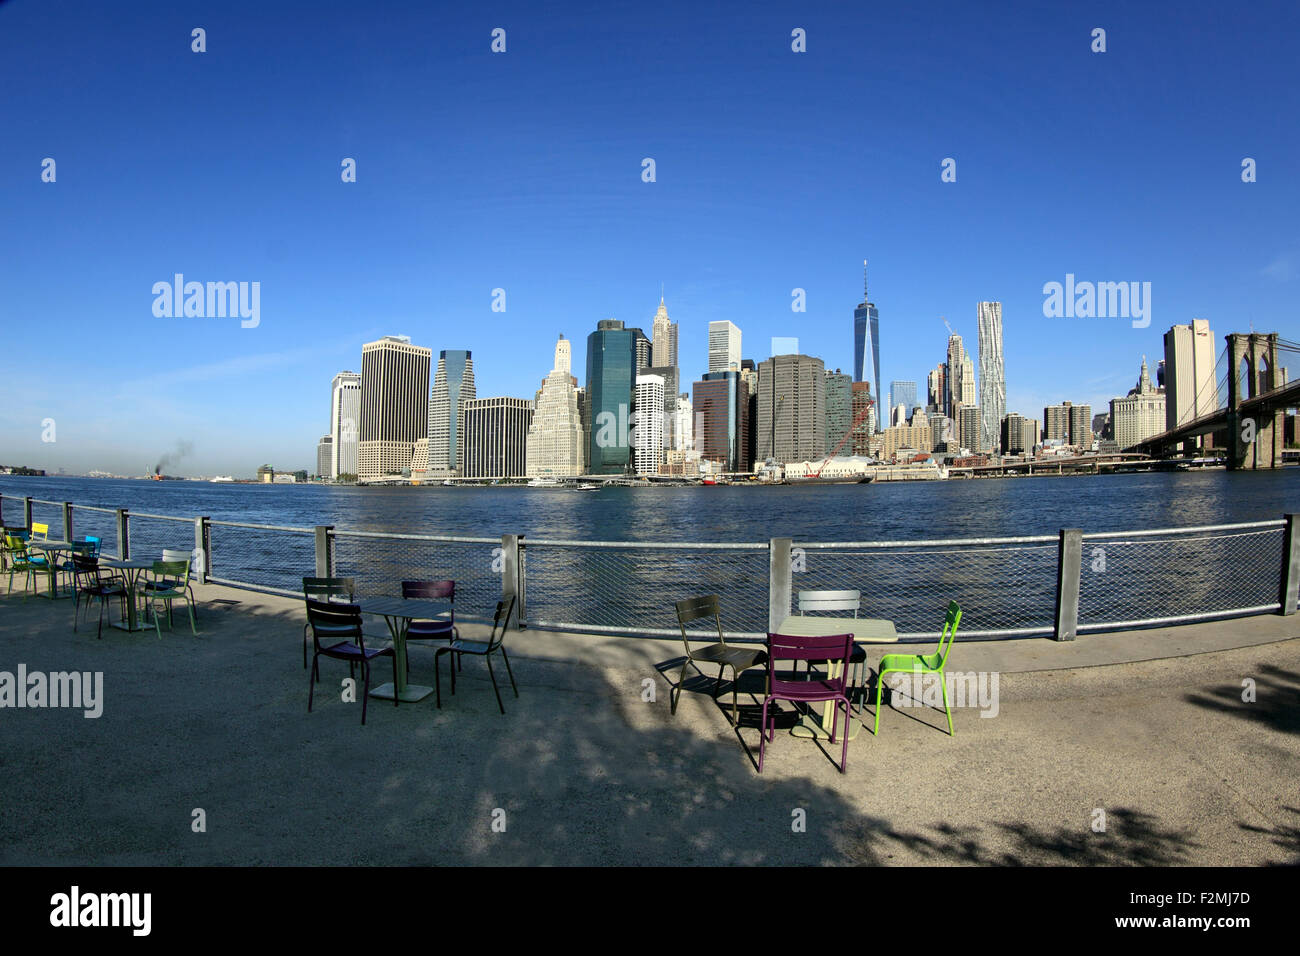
[356, 336, 433, 481]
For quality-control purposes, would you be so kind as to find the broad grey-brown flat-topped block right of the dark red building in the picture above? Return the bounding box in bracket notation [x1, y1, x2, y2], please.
[755, 355, 826, 462]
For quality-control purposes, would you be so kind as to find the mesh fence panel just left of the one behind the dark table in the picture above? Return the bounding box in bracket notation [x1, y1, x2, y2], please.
[210, 522, 316, 594]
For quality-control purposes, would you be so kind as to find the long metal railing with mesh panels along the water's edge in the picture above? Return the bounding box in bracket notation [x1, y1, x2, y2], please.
[0, 496, 1300, 641]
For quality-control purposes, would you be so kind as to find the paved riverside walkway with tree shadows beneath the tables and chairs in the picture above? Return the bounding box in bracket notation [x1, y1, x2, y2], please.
[0, 585, 1300, 865]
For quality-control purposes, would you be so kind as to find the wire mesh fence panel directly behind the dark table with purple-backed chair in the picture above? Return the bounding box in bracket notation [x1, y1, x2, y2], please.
[330, 531, 503, 619]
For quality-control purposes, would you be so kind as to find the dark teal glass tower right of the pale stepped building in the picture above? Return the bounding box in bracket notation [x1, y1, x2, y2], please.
[582, 319, 645, 475]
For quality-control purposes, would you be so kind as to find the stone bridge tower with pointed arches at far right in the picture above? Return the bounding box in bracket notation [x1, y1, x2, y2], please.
[1225, 332, 1286, 471]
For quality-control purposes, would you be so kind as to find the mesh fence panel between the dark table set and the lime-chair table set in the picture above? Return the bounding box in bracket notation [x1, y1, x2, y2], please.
[524, 541, 768, 635]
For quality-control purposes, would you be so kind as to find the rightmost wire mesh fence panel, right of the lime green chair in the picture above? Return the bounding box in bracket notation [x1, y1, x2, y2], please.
[1079, 524, 1283, 626]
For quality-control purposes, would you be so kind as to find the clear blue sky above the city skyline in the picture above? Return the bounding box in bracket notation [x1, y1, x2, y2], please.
[0, 0, 1300, 475]
